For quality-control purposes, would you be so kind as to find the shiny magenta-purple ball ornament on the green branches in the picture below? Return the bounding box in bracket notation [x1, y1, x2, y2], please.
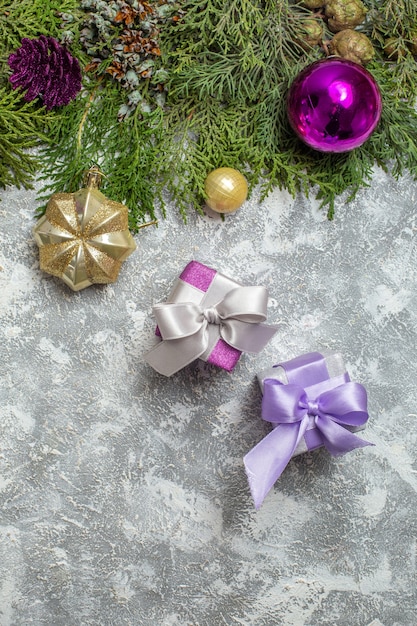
[287, 57, 382, 152]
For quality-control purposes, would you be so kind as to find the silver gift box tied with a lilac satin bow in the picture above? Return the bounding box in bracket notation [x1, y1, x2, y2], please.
[244, 352, 373, 508]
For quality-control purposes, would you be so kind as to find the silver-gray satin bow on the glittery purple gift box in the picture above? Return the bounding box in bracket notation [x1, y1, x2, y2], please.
[145, 286, 276, 376]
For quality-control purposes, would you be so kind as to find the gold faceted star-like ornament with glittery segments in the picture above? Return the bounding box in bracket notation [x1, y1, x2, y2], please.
[33, 168, 140, 291]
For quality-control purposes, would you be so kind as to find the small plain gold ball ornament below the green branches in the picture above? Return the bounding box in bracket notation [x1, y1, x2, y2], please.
[204, 167, 248, 213]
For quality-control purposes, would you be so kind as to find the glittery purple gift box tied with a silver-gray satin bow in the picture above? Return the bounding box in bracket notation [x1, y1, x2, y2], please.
[145, 261, 276, 376]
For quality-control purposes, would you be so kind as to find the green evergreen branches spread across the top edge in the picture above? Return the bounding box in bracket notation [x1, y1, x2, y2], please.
[0, 0, 417, 224]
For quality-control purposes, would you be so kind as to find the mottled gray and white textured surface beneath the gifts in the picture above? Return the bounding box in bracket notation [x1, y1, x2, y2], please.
[0, 170, 417, 626]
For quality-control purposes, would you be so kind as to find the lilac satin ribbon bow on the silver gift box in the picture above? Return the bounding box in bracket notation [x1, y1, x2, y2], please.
[244, 378, 373, 509]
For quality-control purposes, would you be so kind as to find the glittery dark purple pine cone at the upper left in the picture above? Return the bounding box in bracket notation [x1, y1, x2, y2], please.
[8, 35, 81, 110]
